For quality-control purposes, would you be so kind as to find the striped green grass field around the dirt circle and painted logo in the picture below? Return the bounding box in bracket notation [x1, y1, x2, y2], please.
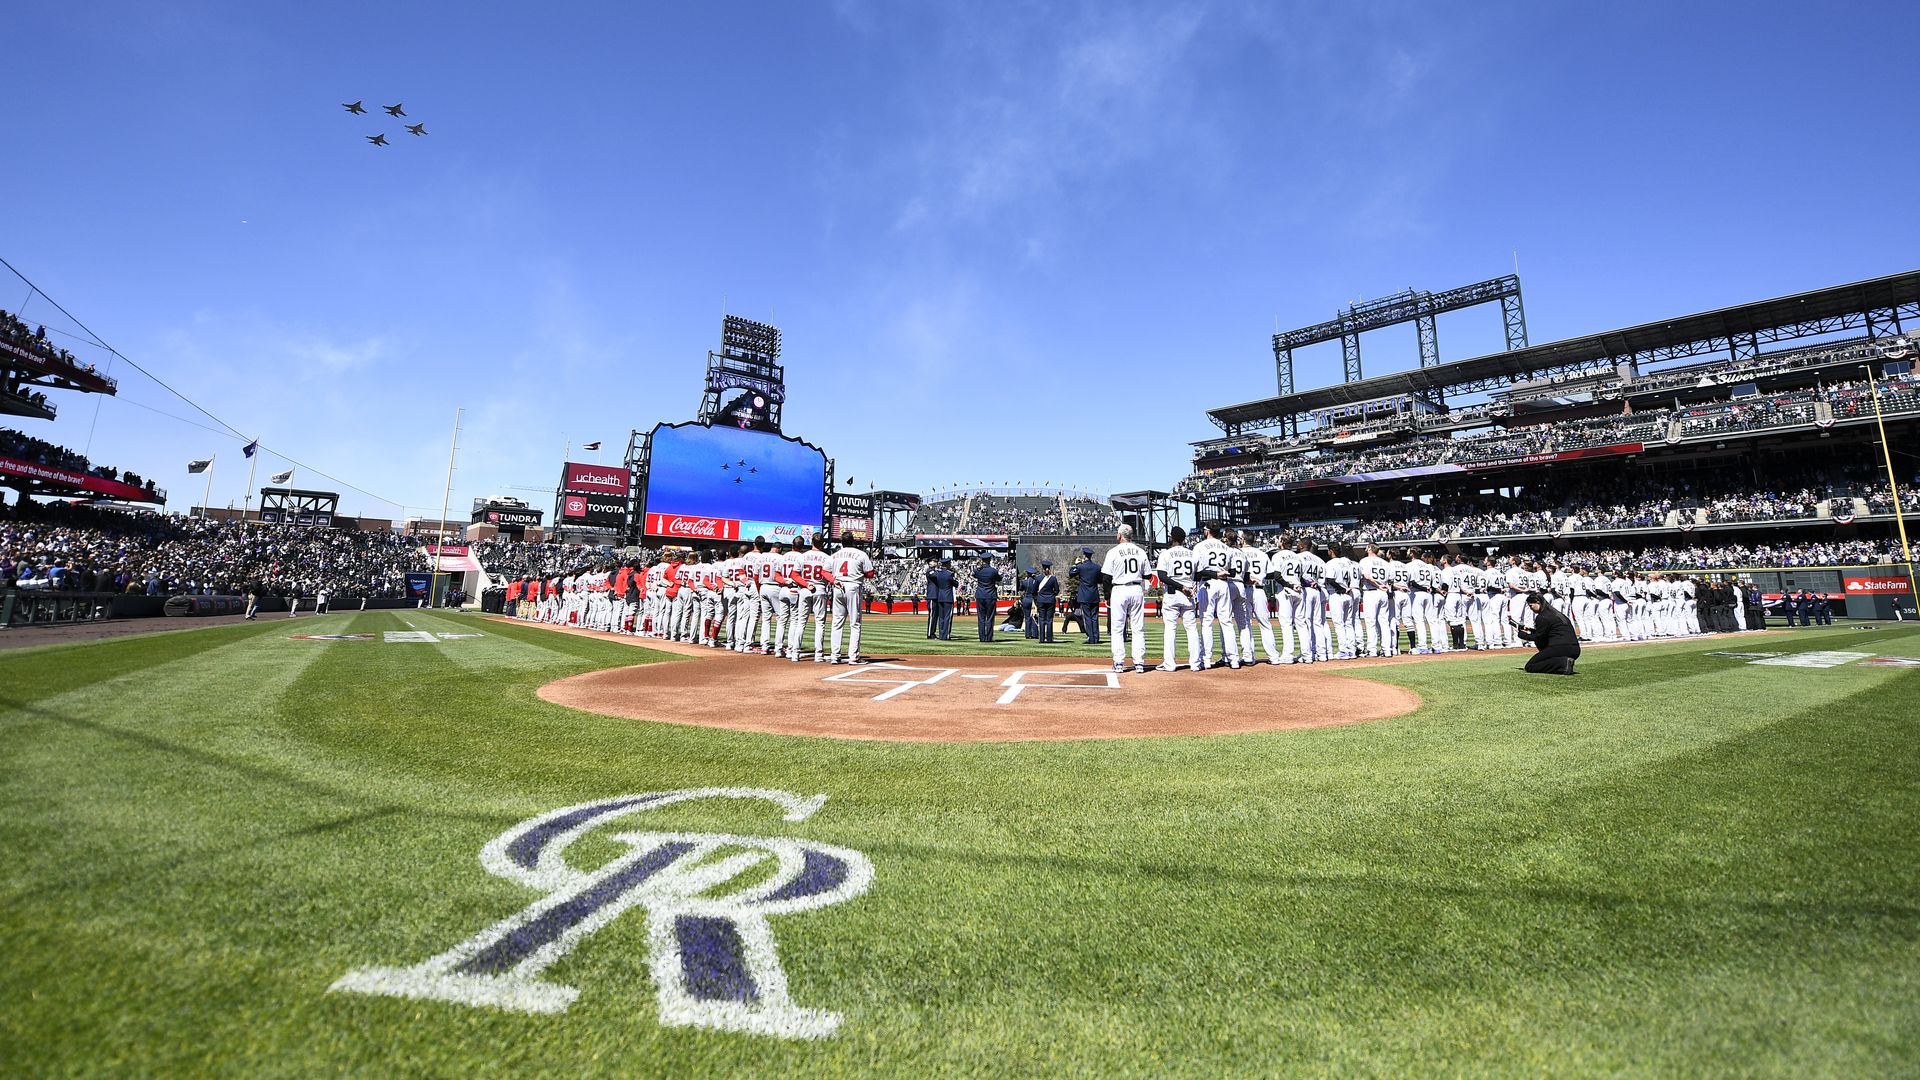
[0, 611, 1920, 1076]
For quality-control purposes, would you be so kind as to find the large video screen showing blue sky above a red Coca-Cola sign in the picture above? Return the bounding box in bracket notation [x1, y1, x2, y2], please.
[645, 423, 828, 540]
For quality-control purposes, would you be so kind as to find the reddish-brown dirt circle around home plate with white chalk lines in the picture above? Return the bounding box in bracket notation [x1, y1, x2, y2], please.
[540, 642, 1421, 742]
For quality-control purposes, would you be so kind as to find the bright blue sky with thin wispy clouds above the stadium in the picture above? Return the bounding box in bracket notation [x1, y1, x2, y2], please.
[0, 0, 1920, 515]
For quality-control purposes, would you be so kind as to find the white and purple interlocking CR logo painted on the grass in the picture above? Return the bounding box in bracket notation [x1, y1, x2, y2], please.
[332, 788, 874, 1038]
